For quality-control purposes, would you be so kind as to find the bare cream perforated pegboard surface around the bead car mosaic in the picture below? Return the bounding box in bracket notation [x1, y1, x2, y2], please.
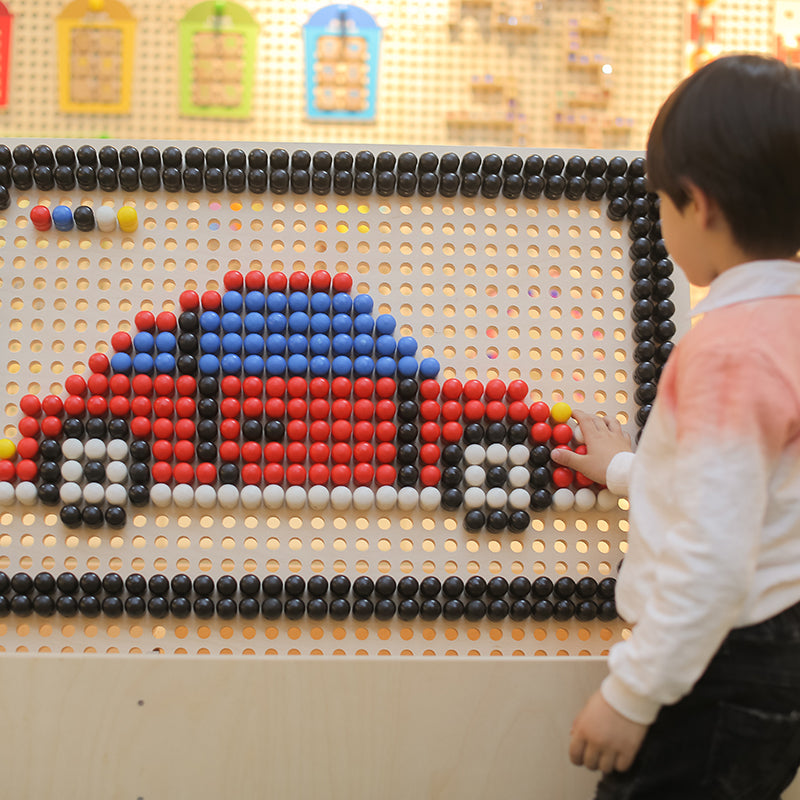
[0, 140, 688, 655]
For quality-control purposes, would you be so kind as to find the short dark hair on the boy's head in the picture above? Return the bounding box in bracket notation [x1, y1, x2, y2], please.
[647, 55, 800, 258]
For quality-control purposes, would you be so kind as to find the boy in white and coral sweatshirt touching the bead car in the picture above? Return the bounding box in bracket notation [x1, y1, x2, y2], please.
[553, 55, 800, 800]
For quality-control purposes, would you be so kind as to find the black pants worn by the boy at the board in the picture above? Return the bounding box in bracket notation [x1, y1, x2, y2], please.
[595, 603, 800, 800]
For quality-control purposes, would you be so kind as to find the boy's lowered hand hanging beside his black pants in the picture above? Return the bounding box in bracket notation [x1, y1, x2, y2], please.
[569, 691, 648, 772]
